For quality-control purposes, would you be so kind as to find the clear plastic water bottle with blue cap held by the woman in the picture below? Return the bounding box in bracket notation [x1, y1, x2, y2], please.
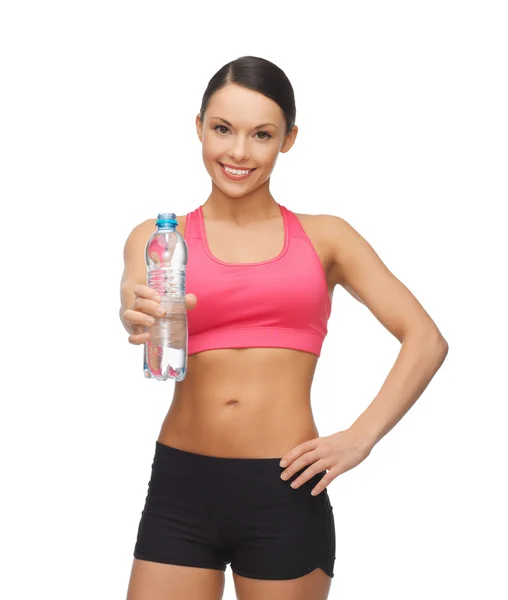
[143, 213, 188, 381]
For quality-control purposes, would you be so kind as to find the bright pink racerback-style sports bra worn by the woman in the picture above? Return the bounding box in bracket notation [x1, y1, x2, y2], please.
[185, 204, 331, 356]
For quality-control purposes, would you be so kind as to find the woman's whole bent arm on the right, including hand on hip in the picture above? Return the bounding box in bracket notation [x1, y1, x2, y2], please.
[281, 215, 448, 493]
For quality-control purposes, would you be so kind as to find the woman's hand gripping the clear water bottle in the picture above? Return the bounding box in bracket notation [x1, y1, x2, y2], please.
[123, 284, 197, 345]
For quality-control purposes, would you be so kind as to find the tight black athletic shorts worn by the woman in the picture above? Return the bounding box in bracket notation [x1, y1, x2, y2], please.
[134, 442, 335, 579]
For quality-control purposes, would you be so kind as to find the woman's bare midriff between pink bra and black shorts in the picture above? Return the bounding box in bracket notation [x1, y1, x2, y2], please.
[158, 348, 318, 458]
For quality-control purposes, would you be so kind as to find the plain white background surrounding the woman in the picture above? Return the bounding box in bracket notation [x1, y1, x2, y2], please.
[0, 0, 508, 600]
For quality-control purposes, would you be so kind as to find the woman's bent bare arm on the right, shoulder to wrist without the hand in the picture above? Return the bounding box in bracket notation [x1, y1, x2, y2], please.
[326, 216, 448, 446]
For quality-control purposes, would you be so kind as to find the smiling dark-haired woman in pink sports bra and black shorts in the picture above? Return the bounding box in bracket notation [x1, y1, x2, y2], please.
[121, 57, 447, 600]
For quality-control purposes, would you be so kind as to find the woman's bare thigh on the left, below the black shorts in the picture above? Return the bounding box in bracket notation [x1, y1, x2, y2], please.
[127, 558, 224, 600]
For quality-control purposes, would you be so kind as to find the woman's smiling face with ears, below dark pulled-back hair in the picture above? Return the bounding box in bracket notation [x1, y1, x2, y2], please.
[196, 83, 298, 198]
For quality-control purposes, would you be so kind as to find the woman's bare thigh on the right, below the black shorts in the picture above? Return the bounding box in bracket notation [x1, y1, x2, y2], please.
[233, 568, 332, 600]
